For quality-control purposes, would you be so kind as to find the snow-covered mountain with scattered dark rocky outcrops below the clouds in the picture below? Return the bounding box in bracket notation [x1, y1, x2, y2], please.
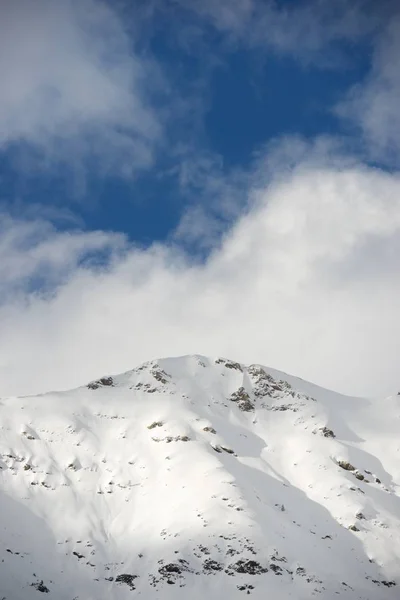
[0, 356, 400, 600]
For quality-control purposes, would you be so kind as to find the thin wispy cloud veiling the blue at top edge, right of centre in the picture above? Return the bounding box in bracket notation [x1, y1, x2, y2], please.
[173, 0, 382, 66]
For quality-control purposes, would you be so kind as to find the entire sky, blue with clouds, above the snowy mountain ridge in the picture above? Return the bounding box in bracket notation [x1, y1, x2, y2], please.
[0, 0, 400, 393]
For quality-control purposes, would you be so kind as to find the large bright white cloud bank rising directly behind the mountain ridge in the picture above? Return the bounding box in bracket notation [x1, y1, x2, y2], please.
[0, 158, 400, 395]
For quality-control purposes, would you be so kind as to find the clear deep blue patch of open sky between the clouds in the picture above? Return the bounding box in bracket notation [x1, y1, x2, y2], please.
[0, 2, 370, 251]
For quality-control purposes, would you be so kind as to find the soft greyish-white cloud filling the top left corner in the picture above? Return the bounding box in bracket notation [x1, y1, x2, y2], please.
[0, 0, 160, 175]
